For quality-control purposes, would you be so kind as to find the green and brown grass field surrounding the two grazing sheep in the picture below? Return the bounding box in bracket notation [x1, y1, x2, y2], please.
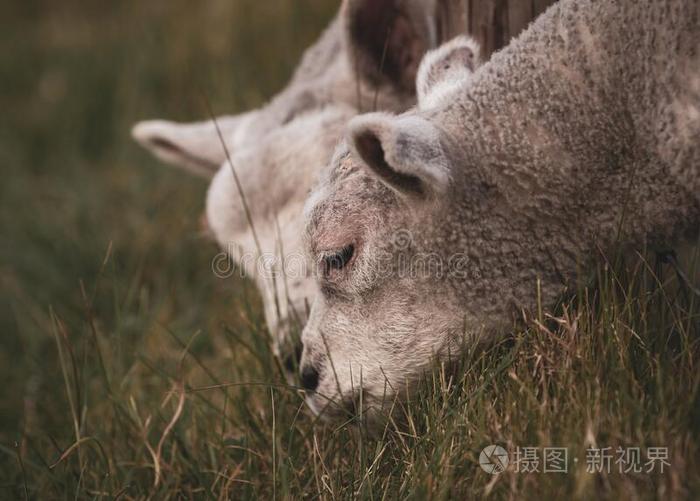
[0, 0, 700, 499]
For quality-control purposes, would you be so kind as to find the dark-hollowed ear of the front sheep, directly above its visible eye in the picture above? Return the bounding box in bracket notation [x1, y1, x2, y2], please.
[348, 113, 451, 198]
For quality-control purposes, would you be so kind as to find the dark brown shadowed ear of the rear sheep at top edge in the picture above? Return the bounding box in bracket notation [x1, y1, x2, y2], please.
[343, 0, 438, 93]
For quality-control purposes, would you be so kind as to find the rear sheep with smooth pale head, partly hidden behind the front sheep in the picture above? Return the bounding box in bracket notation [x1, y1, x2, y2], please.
[133, 0, 470, 364]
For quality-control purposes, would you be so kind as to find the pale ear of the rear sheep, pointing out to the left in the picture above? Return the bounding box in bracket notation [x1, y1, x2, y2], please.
[131, 116, 240, 178]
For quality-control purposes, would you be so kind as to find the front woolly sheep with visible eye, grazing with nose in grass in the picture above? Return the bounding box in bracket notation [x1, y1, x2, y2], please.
[301, 0, 700, 415]
